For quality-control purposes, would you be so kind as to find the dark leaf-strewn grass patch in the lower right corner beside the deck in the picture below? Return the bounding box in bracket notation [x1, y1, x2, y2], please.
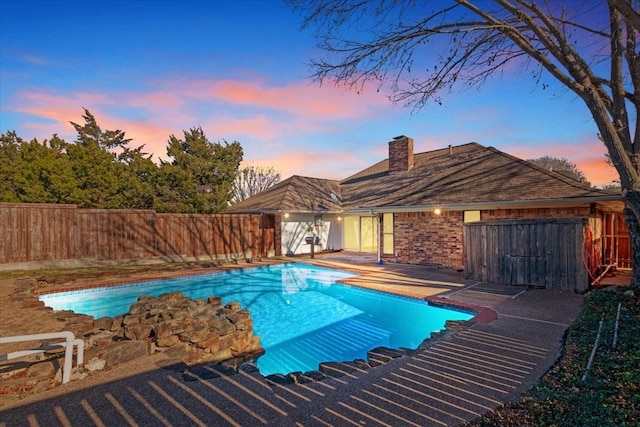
[466, 288, 640, 427]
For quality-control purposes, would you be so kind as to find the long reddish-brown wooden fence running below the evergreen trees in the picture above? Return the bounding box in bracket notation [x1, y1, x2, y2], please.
[0, 203, 275, 270]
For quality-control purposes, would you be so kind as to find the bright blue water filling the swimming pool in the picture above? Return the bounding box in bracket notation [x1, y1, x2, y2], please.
[40, 263, 473, 375]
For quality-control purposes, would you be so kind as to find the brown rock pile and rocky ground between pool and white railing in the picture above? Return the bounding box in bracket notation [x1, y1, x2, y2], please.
[0, 278, 264, 407]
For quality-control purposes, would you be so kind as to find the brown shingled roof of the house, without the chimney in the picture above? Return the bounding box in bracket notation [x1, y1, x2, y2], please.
[228, 142, 620, 212]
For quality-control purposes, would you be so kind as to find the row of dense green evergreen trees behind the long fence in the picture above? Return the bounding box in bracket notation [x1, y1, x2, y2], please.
[0, 109, 242, 213]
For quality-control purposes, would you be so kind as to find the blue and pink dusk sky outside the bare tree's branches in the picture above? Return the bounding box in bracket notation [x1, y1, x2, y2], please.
[0, 0, 617, 185]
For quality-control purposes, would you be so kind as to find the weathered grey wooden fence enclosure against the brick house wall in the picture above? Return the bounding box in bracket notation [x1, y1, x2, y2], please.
[464, 218, 589, 292]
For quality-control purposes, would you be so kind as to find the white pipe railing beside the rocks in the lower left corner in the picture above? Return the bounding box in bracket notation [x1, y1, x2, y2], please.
[0, 331, 84, 384]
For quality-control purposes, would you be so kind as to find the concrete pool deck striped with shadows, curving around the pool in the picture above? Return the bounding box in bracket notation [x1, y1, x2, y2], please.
[0, 253, 583, 427]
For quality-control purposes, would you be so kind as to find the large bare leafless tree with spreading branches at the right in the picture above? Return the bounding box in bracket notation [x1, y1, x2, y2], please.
[289, 0, 640, 289]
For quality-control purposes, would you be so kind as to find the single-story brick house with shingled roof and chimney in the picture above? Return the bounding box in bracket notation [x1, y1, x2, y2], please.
[229, 136, 630, 290]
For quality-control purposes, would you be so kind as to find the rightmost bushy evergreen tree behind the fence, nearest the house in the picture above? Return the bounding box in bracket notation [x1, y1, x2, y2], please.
[156, 127, 242, 213]
